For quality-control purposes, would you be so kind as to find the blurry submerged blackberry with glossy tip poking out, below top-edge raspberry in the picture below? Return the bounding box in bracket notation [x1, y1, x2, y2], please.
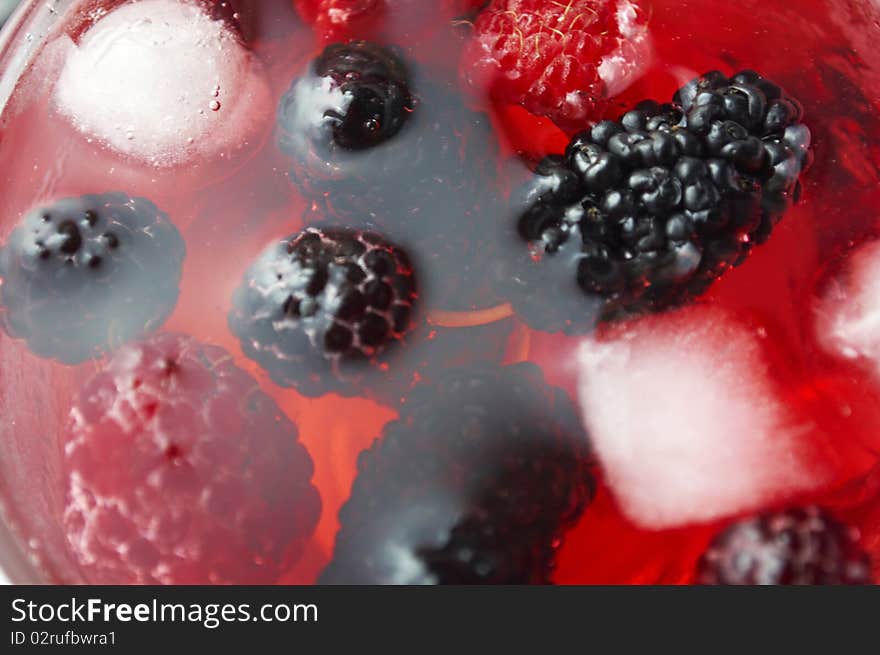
[278, 41, 504, 310]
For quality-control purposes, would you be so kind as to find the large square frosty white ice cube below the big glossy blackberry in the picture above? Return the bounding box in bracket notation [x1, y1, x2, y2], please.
[577, 306, 829, 529]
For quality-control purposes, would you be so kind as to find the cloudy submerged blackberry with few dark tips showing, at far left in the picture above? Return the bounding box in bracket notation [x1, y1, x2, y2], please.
[0, 193, 186, 364]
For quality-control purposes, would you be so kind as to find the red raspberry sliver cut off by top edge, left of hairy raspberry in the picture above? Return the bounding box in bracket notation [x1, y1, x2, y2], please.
[293, 0, 485, 42]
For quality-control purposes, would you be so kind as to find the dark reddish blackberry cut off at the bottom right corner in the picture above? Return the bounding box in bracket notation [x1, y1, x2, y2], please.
[697, 507, 871, 585]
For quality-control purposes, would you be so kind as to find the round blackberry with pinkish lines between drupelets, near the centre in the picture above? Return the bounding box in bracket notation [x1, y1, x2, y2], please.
[229, 227, 417, 396]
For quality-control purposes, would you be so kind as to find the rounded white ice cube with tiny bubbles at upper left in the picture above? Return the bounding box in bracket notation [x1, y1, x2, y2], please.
[54, 0, 269, 166]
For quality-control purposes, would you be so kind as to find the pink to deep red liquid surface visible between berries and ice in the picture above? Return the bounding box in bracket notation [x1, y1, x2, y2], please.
[0, 0, 880, 583]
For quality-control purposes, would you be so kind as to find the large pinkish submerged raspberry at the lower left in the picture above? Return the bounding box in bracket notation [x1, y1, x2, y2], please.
[64, 333, 321, 584]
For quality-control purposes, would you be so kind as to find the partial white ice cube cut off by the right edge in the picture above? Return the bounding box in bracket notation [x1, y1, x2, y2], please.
[816, 241, 880, 376]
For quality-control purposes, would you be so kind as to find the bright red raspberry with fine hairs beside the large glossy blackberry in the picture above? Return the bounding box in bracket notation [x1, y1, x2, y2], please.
[461, 0, 646, 131]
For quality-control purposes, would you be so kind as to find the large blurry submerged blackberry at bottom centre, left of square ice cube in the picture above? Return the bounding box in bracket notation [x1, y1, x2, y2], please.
[319, 364, 593, 584]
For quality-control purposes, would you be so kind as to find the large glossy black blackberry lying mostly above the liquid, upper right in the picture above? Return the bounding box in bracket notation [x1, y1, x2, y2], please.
[507, 71, 810, 332]
